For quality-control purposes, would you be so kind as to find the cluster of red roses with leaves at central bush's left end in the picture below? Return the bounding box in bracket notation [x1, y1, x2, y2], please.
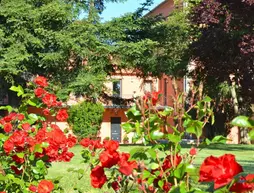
[80, 138, 138, 192]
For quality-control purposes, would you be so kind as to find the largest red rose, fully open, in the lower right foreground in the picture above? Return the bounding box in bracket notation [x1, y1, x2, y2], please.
[199, 154, 243, 189]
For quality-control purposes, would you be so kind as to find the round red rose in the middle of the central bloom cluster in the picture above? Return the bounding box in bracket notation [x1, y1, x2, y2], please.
[99, 151, 119, 168]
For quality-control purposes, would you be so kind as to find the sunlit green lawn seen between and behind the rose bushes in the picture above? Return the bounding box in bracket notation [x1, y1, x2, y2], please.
[48, 145, 254, 193]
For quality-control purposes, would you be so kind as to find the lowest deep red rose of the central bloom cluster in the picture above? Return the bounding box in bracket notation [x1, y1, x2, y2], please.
[90, 166, 107, 188]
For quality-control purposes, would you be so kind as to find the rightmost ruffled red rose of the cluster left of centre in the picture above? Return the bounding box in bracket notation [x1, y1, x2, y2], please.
[118, 153, 138, 176]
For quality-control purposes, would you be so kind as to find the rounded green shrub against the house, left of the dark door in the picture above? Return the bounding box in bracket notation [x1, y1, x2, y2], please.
[68, 101, 104, 138]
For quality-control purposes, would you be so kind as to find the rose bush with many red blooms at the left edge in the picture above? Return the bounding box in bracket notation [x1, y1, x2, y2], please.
[0, 76, 76, 193]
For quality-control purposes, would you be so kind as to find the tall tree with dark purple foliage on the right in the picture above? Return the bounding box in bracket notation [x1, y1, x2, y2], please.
[190, 0, 254, 113]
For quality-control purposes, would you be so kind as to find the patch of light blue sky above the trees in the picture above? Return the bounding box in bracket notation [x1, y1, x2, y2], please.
[101, 0, 163, 21]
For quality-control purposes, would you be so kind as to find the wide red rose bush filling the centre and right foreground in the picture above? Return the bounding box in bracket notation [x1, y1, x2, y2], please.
[80, 89, 254, 193]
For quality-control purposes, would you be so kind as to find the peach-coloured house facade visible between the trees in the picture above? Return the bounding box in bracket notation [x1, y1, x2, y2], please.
[100, 0, 186, 143]
